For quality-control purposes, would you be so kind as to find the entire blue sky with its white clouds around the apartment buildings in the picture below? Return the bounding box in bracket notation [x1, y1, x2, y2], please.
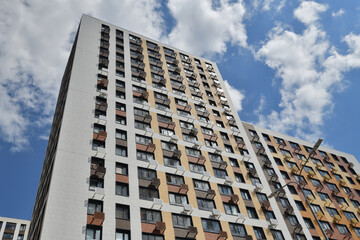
[0, 0, 360, 219]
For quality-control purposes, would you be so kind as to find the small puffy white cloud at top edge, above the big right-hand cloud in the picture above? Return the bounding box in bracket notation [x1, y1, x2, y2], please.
[294, 1, 328, 25]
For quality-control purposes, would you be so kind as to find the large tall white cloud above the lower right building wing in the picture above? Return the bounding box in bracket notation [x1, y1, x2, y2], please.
[256, 2, 360, 141]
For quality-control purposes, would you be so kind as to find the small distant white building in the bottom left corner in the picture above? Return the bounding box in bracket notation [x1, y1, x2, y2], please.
[0, 217, 30, 240]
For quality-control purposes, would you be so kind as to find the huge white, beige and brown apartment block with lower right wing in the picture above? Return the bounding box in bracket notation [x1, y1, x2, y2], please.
[28, 15, 360, 240]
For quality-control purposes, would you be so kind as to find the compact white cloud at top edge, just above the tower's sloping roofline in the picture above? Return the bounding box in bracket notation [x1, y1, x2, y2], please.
[164, 0, 247, 56]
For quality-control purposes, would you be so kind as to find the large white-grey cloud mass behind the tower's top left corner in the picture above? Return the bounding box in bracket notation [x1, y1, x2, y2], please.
[0, 0, 163, 151]
